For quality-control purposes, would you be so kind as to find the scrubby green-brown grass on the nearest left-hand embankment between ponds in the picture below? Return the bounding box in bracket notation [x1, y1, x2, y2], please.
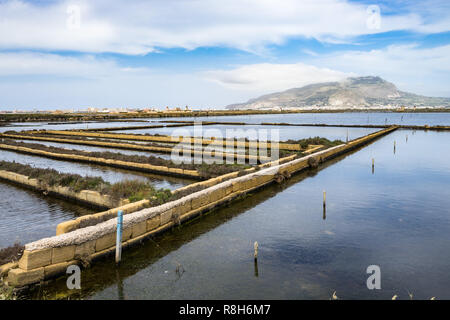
[0, 161, 172, 205]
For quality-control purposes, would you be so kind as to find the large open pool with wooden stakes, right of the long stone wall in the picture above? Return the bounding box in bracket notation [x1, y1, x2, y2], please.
[22, 130, 450, 299]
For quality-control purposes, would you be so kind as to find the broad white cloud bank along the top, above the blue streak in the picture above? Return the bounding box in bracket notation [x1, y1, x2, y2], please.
[0, 0, 450, 54]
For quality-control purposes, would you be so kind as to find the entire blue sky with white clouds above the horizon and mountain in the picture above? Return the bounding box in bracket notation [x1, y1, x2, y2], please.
[0, 0, 450, 111]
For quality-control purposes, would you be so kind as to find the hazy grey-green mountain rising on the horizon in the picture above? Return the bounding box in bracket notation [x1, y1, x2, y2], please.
[227, 76, 450, 109]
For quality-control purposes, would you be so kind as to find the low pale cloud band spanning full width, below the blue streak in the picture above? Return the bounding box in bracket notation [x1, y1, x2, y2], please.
[0, 44, 450, 110]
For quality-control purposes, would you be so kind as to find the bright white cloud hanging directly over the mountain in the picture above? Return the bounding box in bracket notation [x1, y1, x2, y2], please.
[203, 44, 450, 97]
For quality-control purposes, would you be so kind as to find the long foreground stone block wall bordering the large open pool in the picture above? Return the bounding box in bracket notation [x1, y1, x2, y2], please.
[2, 127, 397, 286]
